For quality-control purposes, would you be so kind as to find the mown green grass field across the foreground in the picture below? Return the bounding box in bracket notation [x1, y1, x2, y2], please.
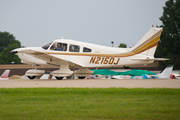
[0, 88, 180, 120]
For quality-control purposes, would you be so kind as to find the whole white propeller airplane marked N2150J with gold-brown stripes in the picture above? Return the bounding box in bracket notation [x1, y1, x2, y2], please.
[11, 28, 169, 80]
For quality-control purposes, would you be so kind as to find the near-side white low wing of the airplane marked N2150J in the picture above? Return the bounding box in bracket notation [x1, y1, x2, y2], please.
[17, 49, 82, 66]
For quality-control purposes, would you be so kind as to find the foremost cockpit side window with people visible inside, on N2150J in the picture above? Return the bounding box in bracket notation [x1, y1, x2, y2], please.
[50, 42, 67, 51]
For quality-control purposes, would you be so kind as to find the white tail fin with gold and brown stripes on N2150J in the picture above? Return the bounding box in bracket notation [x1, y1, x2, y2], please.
[131, 28, 162, 56]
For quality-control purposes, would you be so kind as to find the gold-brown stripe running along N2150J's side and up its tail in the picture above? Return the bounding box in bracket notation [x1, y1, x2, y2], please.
[45, 35, 160, 57]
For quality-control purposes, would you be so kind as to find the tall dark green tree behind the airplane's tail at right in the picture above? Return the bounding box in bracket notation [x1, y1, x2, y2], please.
[155, 0, 180, 69]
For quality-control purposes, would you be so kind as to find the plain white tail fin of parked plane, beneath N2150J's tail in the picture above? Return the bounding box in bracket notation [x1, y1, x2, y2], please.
[158, 65, 173, 79]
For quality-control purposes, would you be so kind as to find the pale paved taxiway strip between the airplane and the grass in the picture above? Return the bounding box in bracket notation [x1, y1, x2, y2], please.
[0, 79, 180, 88]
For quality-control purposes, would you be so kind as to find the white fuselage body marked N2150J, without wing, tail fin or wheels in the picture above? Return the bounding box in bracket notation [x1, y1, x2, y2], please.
[14, 39, 153, 67]
